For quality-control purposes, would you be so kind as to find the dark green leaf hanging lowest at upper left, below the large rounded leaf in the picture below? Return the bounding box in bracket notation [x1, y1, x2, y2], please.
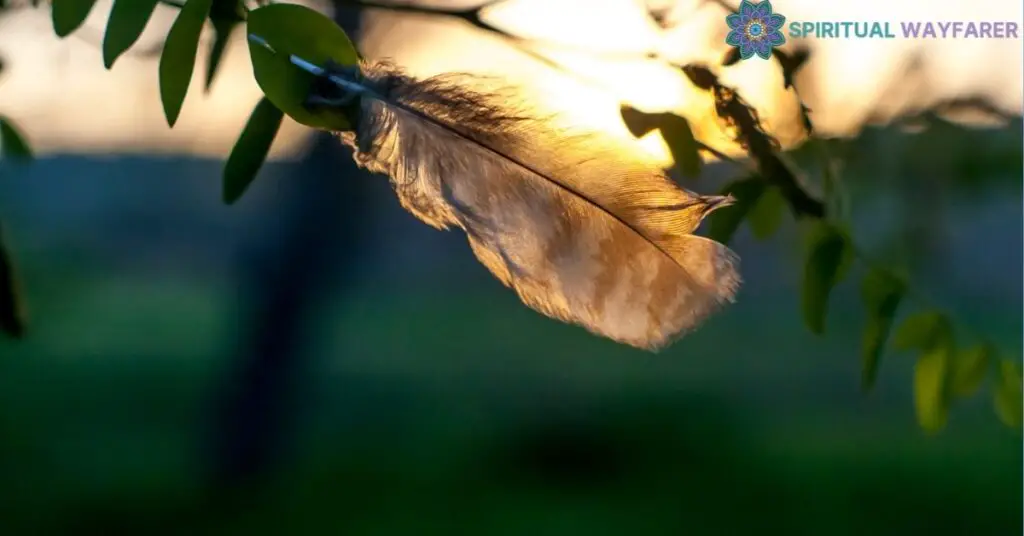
[223, 97, 285, 204]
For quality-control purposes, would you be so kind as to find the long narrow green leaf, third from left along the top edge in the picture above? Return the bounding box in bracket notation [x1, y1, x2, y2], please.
[154, 0, 213, 127]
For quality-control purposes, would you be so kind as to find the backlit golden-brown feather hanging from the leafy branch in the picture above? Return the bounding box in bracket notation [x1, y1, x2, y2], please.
[314, 61, 740, 351]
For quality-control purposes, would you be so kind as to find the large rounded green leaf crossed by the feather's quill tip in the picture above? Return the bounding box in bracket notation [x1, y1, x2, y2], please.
[248, 4, 359, 131]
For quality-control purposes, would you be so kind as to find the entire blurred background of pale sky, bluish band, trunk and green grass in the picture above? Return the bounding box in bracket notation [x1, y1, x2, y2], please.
[0, 0, 1024, 536]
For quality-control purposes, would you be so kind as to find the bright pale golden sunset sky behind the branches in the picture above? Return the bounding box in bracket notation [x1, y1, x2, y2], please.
[0, 0, 1024, 163]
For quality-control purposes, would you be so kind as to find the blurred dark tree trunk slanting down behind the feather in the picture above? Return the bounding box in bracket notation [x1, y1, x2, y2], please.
[210, 5, 369, 496]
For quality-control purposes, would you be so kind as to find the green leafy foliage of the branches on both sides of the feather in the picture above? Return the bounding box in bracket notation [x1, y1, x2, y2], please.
[0, 0, 1021, 431]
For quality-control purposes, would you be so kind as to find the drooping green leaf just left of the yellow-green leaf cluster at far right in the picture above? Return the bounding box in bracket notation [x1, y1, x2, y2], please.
[860, 270, 906, 390]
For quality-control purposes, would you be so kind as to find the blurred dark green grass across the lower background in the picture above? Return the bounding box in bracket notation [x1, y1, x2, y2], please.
[0, 272, 1022, 536]
